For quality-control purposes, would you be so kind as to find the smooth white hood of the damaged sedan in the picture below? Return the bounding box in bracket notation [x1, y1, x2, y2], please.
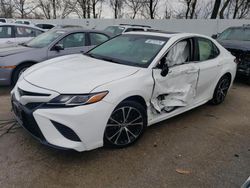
[24, 54, 140, 94]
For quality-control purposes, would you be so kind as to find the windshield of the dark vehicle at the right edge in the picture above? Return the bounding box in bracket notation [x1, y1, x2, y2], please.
[218, 28, 250, 41]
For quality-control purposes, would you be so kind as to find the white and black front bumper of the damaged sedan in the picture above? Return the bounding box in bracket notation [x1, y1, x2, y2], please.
[12, 80, 114, 151]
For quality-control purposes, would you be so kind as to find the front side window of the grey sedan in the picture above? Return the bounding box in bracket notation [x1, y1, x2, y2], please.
[59, 33, 85, 48]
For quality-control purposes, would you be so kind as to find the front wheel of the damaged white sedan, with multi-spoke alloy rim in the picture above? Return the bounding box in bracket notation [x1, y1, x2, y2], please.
[104, 101, 147, 148]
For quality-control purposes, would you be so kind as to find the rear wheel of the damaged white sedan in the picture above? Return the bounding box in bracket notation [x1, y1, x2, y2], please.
[210, 75, 231, 105]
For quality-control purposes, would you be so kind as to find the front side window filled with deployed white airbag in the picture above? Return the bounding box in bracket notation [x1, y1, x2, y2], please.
[165, 40, 191, 67]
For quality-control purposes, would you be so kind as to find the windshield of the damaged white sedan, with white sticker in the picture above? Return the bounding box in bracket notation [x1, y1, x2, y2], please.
[86, 35, 168, 67]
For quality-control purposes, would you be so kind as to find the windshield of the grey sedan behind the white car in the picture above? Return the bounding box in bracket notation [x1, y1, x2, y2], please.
[25, 31, 65, 48]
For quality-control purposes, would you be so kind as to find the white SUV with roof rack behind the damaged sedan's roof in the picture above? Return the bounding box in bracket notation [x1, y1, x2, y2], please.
[104, 24, 151, 37]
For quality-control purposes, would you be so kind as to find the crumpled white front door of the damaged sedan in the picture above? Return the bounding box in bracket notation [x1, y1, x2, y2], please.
[151, 64, 199, 113]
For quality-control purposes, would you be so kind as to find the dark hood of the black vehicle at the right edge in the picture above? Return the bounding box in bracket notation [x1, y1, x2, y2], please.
[218, 40, 250, 51]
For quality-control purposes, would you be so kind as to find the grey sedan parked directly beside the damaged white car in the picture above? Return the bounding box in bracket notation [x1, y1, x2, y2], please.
[0, 28, 110, 85]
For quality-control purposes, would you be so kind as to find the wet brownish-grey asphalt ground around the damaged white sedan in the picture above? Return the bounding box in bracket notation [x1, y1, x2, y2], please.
[0, 79, 250, 188]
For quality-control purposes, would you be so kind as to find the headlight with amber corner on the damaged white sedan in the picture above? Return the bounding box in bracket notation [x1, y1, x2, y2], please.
[48, 91, 108, 106]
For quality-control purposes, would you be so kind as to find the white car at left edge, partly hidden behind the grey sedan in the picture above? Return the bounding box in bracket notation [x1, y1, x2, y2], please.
[0, 23, 44, 47]
